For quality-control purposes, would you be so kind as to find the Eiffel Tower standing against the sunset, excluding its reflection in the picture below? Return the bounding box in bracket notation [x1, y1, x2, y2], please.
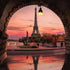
[31, 8, 41, 37]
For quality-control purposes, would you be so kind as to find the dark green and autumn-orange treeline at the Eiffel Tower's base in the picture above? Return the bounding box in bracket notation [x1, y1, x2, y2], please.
[19, 33, 65, 43]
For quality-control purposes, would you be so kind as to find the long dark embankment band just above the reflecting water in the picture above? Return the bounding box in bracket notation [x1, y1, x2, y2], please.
[7, 48, 65, 56]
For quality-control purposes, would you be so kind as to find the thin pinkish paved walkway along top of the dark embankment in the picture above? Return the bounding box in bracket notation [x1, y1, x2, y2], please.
[7, 46, 65, 50]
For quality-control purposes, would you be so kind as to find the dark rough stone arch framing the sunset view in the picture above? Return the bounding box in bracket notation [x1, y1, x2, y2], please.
[0, 0, 70, 69]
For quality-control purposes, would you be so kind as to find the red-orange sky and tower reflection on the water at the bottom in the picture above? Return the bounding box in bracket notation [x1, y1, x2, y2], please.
[8, 56, 64, 70]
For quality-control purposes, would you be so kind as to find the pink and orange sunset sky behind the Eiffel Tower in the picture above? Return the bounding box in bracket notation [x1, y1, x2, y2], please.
[6, 5, 65, 39]
